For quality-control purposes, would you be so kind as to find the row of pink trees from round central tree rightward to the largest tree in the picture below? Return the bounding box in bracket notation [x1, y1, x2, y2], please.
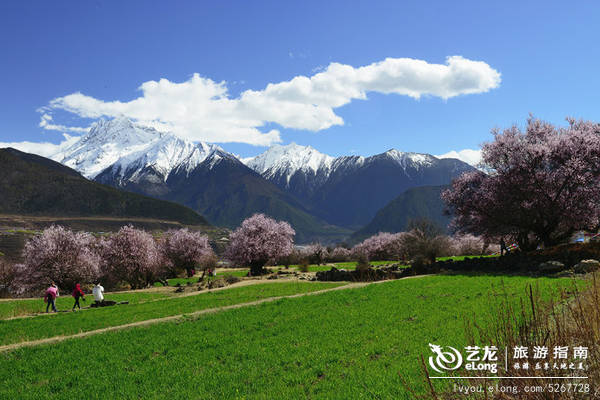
[225, 214, 492, 274]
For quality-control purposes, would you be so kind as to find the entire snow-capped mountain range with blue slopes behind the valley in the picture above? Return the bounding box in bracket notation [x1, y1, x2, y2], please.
[39, 118, 473, 243]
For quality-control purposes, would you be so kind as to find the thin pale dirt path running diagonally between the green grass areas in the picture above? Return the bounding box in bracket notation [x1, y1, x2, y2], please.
[0, 275, 429, 352]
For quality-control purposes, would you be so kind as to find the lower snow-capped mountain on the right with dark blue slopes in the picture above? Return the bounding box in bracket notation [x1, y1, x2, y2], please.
[244, 144, 472, 228]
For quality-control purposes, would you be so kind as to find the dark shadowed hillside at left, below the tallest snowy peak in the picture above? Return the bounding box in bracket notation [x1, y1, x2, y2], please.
[0, 148, 208, 225]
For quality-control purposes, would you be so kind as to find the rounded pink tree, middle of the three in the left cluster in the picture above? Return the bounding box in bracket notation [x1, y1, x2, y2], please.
[100, 225, 164, 289]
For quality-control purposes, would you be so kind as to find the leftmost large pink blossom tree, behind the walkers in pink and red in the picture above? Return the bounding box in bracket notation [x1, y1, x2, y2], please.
[14, 226, 100, 292]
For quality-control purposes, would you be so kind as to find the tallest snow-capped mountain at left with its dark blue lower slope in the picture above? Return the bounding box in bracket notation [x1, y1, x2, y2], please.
[53, 118, 349, 242]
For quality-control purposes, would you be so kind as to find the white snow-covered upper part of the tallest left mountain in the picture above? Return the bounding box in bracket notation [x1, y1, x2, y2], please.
[53, 118, 224, 181]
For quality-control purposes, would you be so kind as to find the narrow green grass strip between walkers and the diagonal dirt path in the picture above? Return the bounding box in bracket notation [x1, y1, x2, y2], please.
[0, 282, 343, 345]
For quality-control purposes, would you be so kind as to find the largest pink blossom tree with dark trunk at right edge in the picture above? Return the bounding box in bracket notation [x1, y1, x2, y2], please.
[442, 117, 600, 250]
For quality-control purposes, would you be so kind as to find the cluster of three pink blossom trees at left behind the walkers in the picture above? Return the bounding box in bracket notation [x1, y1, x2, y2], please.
[4, 226, 215, 292]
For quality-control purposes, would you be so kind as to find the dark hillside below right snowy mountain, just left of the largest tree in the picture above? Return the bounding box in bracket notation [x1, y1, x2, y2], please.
[351, 186, 450, 242]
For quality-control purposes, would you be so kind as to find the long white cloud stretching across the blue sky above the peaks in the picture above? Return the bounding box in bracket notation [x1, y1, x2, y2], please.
[40, 56, 500, 145]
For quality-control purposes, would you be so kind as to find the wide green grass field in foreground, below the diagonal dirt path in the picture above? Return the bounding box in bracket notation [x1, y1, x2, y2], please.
[0, 275, 572, 399]
